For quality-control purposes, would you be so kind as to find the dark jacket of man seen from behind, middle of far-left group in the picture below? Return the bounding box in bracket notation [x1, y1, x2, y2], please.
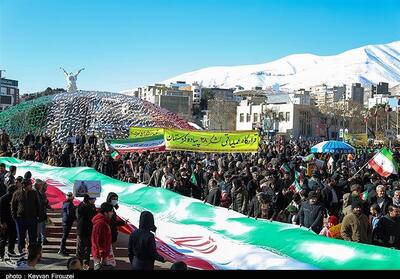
[11, 188, 40, 219]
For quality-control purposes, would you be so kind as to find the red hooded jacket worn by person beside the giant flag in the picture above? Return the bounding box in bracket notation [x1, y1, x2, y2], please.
[91, 213, 112, 259]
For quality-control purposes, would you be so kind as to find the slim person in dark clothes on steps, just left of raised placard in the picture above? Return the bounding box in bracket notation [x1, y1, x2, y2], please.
[58, 192, 76, 256]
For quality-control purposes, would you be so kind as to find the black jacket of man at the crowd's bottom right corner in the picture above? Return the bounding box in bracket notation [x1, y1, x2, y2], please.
[375, 215, 400, 249]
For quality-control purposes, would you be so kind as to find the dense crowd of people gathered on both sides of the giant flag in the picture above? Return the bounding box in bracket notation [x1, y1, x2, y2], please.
[0, 131, 400, 269]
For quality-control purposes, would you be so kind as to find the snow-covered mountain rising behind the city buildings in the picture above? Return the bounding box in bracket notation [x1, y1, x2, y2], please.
[160, 41, 400, 89]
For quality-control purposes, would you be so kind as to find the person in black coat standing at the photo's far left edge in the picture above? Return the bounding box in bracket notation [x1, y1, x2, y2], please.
[0, 185, 17, 258]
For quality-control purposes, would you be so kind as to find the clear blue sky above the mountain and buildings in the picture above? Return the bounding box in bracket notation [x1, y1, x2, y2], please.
[0, 0, 400, 93]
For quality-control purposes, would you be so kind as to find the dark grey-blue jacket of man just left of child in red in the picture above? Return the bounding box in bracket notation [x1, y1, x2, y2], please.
[299, 201, 324, 234]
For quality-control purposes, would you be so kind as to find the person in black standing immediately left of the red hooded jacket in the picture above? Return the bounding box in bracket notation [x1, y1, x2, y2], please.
[76, 194, 96, 266]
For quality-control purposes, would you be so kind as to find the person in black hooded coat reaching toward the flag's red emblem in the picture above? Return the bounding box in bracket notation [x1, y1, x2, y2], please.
[128, 211, 165, 270]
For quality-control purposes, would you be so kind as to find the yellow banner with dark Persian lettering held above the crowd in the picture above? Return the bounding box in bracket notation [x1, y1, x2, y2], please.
[164, 129, 260, 153]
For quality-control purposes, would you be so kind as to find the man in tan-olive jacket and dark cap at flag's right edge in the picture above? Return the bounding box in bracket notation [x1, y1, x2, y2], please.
[340, 199, 372, 244]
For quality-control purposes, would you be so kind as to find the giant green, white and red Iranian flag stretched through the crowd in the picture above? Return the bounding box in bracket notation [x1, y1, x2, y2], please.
[0, 158, 400, 269]
